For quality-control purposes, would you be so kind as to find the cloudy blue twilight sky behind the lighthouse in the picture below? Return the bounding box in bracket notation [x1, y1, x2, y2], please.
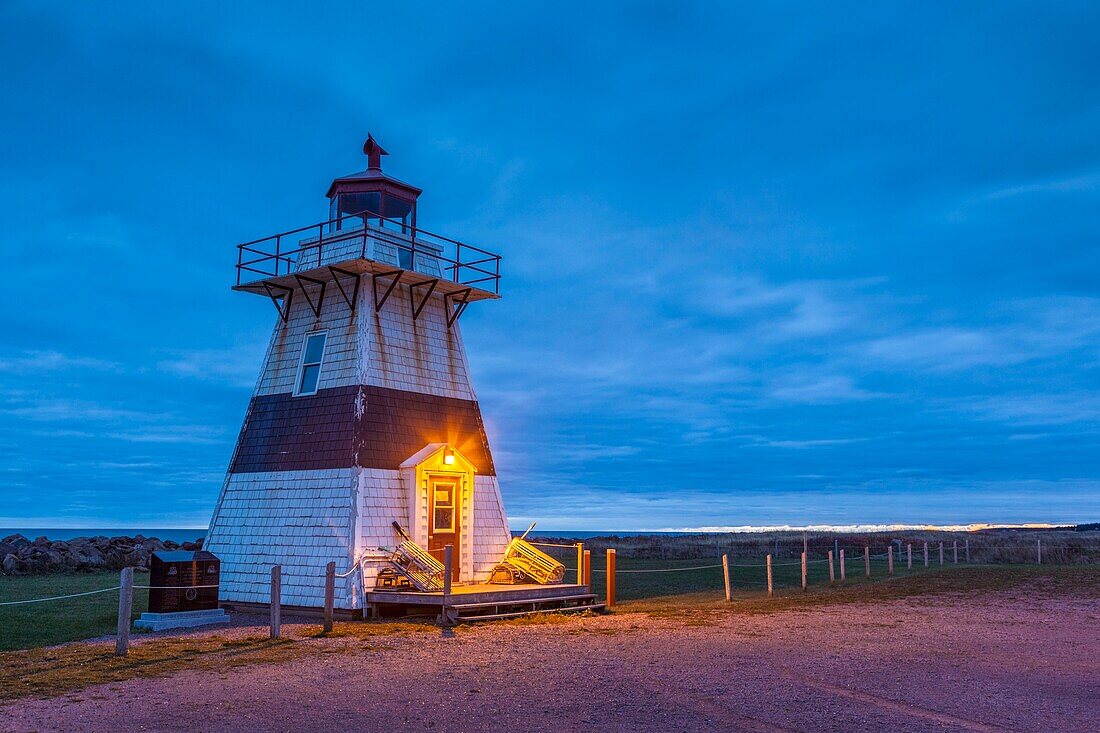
[0, 2, 1100, 529]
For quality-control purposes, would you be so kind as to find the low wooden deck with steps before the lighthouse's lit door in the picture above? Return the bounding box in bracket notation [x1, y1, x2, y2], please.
[366, 583, 604, 621]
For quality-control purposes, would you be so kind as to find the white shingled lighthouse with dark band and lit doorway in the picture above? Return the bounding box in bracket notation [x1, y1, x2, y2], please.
[206, 136, 510, 611]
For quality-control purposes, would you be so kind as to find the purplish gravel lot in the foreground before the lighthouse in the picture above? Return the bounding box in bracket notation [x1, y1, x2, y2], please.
[0, 591, 1100, 733]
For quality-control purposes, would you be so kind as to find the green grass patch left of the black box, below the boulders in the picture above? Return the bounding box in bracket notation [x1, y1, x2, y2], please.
[0, 572, 149, 652]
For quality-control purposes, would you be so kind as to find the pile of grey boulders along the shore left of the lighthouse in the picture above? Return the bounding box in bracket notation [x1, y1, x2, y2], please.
[0, 535, 202, 576]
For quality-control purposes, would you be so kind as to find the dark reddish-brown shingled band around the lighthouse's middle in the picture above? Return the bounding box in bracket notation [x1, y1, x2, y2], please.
[229, 386, 496, 475]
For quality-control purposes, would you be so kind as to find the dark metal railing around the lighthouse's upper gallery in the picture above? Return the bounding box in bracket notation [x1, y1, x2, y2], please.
[237, 206, 501, 295]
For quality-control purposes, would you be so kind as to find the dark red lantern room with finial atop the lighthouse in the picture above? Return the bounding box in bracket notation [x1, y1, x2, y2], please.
[327, 135, 421, 233]
